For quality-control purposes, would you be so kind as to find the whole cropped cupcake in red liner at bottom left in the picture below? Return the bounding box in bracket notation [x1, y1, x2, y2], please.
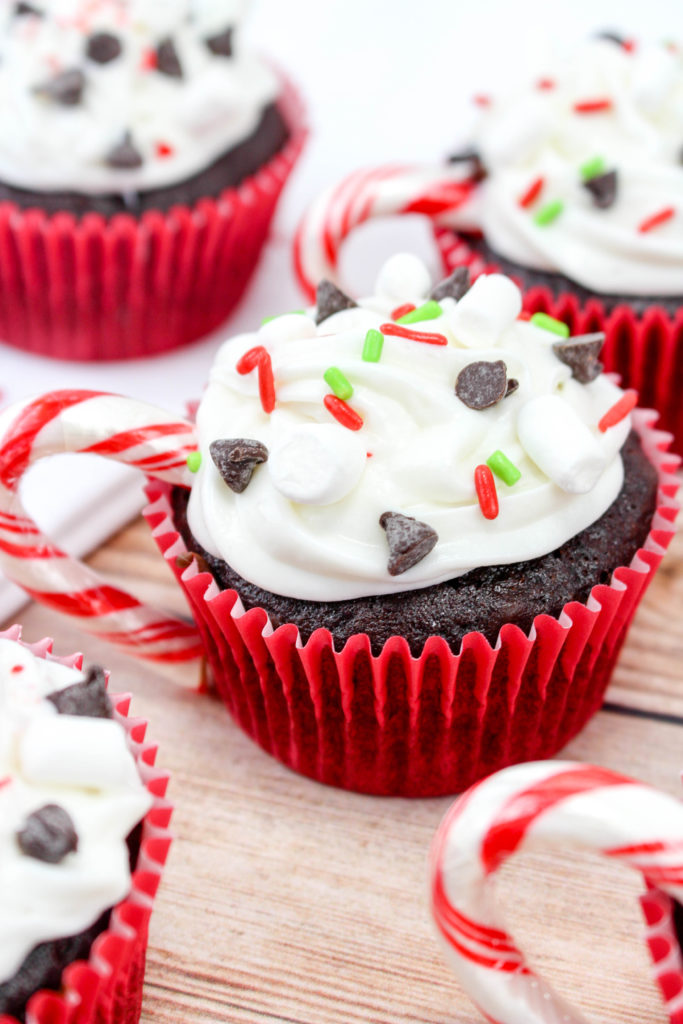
[0, 627, 169, 1024]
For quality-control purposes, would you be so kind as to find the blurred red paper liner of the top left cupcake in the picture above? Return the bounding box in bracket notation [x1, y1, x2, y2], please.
[0, 73, 306, 360]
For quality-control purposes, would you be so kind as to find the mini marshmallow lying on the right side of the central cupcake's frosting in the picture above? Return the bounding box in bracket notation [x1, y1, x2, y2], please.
[517, 394, 606, 495]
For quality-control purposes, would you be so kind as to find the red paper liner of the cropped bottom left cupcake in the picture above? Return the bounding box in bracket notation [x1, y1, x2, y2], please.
[0, 626, 172, 1024]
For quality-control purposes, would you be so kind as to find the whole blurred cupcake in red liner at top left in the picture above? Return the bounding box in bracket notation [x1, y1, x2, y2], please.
[0, 0, 303, 359]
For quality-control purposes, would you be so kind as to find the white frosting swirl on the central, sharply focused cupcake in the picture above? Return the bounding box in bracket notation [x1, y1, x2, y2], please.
[188, 257, 630, 600]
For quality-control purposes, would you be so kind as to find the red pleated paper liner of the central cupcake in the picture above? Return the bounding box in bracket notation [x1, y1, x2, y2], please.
[144, 410, 679, 797]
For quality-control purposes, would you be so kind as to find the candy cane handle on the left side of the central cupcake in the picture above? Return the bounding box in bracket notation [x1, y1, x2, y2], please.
[0, 390, 202, 662]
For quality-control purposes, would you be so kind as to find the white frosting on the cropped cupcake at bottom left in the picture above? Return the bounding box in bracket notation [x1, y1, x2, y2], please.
[0, 639, 152, 983]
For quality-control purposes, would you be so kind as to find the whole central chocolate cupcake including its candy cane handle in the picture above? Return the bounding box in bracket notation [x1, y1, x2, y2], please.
[0, 255, 677, 796]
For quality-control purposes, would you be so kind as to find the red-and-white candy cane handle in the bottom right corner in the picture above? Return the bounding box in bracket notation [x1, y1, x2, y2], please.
[431, 761, 683, 1024]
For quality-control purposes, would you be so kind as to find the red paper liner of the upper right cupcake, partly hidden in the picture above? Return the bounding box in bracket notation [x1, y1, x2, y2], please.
[435, 228, 683, 453]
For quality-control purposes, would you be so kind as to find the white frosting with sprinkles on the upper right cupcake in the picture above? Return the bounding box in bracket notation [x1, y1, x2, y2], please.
[457, 39, 683, 296]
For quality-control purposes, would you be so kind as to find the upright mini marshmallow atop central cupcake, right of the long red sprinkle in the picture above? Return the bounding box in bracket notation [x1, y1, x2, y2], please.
[446, 273, 522, 348]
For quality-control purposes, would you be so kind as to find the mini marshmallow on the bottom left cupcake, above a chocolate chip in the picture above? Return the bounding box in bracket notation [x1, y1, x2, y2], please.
[19, 715, 138, 790]
